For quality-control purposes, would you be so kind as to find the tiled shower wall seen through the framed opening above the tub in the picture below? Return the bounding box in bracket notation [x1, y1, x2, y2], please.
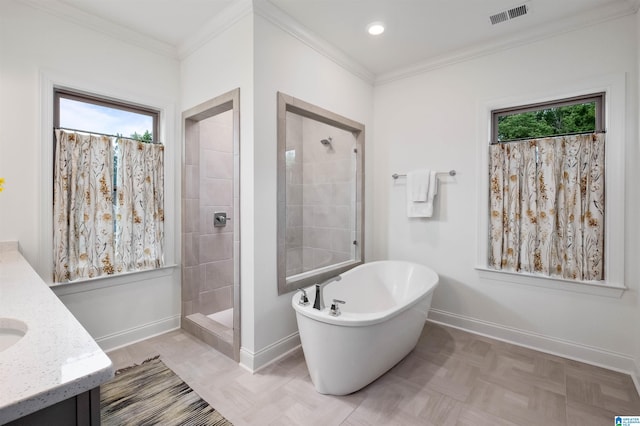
[285, 112, 355, 275]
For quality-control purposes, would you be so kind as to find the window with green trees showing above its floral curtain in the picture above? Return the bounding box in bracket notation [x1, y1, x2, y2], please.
[488, 93, 606, 281]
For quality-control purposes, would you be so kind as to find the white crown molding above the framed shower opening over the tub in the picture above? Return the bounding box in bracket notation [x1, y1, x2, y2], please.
[253, 0, 375, 84]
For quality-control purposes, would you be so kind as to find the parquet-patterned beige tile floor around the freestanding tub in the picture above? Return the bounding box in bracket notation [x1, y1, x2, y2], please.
[108, 322, 640, 426]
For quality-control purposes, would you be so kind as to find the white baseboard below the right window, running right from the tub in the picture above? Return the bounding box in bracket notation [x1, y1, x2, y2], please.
[428, 309, 640, 376]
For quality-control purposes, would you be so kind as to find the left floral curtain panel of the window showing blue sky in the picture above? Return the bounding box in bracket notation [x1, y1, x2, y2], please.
[53, 130, 114, 282]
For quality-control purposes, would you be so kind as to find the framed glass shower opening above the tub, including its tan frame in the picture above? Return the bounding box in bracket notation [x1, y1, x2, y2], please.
[278, 93, 364, 294]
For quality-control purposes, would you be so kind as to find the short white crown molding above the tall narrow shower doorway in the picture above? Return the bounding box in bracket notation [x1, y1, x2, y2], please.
[177, 0, 253, 60]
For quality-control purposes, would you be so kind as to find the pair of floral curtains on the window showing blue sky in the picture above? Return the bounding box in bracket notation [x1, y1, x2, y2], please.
[53, 130, 164, 283]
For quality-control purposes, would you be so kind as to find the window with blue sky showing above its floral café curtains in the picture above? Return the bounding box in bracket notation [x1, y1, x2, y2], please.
[53, 90, 164, 283]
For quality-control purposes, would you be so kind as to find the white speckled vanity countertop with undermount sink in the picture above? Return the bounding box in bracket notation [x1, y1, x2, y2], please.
[0, 242, 114, 424]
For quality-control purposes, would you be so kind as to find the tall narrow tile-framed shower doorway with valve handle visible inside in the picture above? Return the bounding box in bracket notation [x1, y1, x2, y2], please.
[181, 89, 240, 360]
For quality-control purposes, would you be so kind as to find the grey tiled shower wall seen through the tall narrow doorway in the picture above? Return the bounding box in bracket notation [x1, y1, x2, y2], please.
[182, 110, 235, 317]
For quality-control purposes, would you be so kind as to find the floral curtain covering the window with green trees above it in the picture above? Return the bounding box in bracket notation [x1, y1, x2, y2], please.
[489, 134, 605, 281]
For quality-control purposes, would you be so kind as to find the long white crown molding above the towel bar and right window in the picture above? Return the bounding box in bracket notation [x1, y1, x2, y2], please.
[374, 0, 640, 86]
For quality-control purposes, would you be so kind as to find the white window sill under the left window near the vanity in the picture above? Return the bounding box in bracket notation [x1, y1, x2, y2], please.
[49, 265, 178, 296]
